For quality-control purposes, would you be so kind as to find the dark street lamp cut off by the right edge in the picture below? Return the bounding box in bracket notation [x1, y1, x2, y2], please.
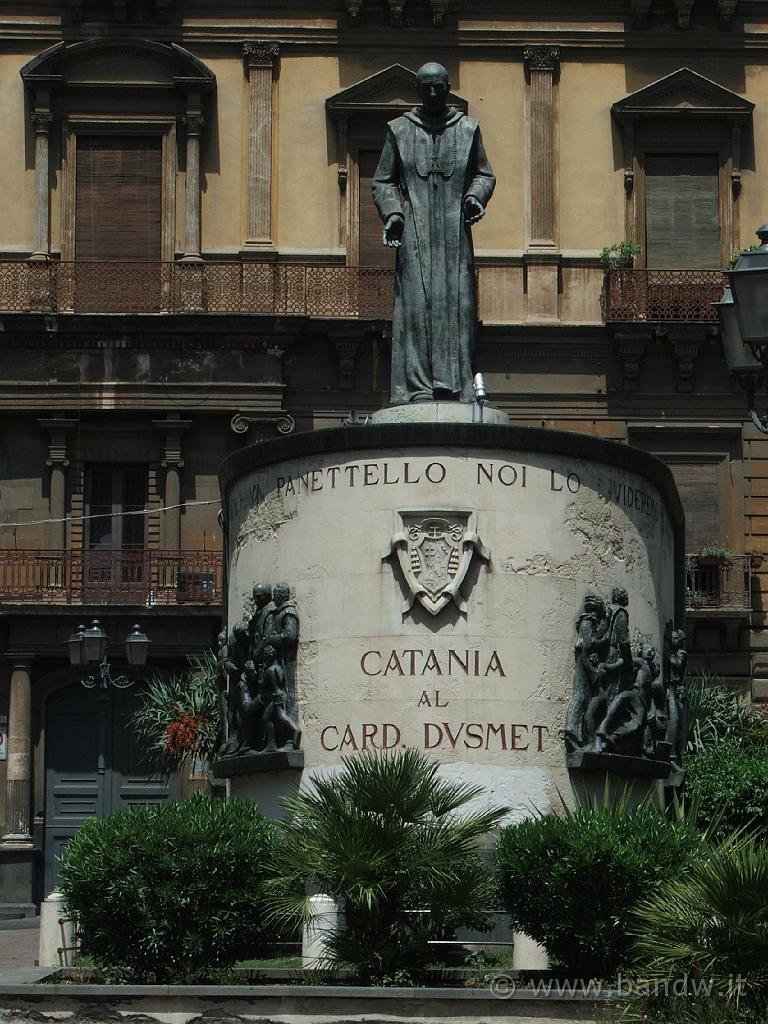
[714, 224, 768, 434]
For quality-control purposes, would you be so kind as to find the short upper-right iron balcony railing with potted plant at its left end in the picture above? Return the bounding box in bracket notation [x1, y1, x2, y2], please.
[603, 269, 725, 323]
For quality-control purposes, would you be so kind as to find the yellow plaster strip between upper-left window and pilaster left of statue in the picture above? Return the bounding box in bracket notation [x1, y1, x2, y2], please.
[198, 52, 243, 253]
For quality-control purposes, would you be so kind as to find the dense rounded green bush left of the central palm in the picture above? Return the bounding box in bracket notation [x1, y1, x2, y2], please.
[60, 795, 272, 983]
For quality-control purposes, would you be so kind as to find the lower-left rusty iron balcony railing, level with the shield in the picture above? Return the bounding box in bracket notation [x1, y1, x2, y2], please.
[0, 550, 222, 607]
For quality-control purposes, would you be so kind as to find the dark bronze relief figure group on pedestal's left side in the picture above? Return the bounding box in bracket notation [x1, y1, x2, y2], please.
[217, 583, 301, 758]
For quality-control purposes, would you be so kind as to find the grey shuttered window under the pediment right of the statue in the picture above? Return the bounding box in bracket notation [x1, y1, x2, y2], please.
[645, 153, 721, 270]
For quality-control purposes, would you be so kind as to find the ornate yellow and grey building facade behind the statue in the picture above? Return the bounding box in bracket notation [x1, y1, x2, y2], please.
[0, 0, 768, 913]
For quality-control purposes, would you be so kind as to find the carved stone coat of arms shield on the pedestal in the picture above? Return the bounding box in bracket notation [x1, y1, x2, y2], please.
[384, 511, 490, 615]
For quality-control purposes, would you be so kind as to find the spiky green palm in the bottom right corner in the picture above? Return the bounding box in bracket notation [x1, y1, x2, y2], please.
[633, 835, 768, 1021]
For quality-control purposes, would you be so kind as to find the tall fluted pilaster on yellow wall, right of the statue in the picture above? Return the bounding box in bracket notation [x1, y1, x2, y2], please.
[523, 46, 560, 321]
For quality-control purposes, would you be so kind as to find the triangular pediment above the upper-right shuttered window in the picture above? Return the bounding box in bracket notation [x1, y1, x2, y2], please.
[612, 68, 755, 120]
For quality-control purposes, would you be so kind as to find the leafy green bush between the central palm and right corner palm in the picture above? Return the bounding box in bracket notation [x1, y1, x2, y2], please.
[497, 806, 700, 979]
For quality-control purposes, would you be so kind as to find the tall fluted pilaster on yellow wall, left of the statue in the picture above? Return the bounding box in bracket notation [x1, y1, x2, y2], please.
[243, 41, 280, 249]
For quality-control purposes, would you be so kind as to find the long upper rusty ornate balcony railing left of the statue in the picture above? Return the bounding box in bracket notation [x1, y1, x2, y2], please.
[0, 260, 394, 319]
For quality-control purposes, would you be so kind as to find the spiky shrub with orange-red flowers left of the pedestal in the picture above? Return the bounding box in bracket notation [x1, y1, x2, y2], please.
[131, 650, 221, 772]
